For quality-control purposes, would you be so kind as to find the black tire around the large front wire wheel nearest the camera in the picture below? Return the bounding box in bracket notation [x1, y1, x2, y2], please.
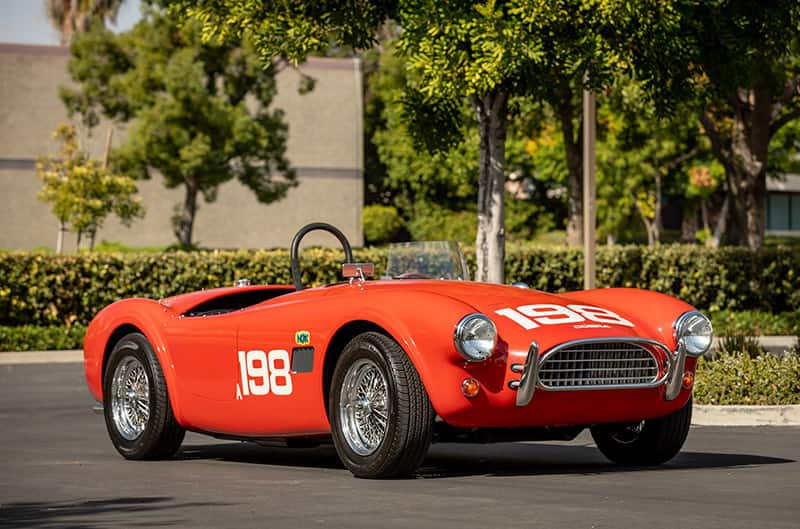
[329, 332, 434, 478]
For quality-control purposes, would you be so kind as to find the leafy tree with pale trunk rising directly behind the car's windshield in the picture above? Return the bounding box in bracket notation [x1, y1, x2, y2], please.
[173, 0, 692, 282]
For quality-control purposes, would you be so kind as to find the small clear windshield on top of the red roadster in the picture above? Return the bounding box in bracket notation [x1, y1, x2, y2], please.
[386, 241, 469, 281]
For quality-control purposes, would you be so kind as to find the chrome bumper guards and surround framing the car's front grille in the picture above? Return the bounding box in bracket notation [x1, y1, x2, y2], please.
[508, 337, 686, 407]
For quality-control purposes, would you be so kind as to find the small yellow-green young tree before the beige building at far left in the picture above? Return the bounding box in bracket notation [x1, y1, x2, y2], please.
[36, 125, 144, 253]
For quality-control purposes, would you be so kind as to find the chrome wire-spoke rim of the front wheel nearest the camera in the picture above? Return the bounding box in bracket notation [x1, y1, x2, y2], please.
[339, 358, 389, 456]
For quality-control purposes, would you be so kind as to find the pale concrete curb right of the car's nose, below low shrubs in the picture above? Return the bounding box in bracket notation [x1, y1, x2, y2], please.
[692, 404, 800, 426]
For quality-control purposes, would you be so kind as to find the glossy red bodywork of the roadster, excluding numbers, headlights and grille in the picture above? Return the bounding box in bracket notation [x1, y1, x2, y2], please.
[84, 280, 695, 437]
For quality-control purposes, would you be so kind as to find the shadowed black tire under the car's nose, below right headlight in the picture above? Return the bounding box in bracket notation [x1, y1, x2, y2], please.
[591, 398, 692, 466]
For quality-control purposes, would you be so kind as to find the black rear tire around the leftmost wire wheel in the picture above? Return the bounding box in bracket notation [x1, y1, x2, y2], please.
[103, 333, 186, 459]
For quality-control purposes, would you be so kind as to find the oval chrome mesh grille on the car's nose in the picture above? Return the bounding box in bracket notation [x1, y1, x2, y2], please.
[539, 341, 659, 390]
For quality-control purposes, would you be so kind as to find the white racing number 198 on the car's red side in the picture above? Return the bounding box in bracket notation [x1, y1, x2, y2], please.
[239, 349, 292, 397]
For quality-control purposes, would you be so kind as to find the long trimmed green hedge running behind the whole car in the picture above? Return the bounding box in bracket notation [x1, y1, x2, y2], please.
[0, 245, 800, 326]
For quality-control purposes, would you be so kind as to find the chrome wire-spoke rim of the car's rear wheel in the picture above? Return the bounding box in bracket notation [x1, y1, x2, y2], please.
[111, 356, 150, 441]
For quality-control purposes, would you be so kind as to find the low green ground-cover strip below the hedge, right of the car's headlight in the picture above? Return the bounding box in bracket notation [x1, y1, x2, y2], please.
[709, 308, 800, 336]
